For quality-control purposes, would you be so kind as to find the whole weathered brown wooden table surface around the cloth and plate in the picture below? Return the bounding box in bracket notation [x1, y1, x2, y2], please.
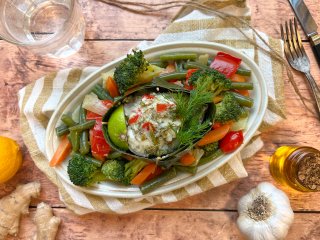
[0, 0, 320, 240]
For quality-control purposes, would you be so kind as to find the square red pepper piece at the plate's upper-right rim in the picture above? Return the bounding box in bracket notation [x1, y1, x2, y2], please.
[210, 52, 241, 78]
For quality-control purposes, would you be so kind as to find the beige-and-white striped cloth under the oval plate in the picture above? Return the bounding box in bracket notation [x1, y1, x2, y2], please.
[19, 0, 285, 214]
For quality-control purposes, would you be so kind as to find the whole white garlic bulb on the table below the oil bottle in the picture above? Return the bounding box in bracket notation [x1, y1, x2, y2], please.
[237, 182, 293, 240]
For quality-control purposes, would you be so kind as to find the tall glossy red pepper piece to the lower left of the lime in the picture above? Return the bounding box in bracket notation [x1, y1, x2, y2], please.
[90, 119, 111, 160]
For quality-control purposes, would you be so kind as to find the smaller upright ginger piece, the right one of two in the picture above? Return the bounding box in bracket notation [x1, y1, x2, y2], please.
[34, 203, 61, 240]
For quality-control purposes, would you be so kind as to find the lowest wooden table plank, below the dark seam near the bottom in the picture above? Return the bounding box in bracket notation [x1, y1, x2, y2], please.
[8, 209, 320, 240]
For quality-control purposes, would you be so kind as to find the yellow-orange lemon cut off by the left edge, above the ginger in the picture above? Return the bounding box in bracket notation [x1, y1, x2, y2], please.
[0, 136, 22, 183]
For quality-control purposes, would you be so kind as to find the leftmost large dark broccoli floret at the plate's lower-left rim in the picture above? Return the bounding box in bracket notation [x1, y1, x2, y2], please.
[68, 153, 106, 186]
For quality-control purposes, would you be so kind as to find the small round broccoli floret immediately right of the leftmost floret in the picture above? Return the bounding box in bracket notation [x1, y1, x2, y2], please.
[101, 159, 125, 182]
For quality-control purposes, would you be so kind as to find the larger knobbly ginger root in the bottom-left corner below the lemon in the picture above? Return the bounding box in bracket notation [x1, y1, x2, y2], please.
[0, 182, 40, 240]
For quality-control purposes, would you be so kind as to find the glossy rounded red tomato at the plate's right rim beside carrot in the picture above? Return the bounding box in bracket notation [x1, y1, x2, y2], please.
[219, 131, 243, 153]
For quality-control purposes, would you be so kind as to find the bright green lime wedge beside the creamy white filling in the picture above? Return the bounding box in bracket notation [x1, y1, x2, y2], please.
[108, 105, 129, 150]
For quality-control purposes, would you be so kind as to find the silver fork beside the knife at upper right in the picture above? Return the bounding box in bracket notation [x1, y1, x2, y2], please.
[280, 18, 320, 117]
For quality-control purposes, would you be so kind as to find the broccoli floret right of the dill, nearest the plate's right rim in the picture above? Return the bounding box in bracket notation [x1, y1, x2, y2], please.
[215, 92, 243, 123]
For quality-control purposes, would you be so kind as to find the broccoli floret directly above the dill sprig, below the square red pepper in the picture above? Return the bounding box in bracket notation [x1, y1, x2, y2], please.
[188, 68, 231, 97]
